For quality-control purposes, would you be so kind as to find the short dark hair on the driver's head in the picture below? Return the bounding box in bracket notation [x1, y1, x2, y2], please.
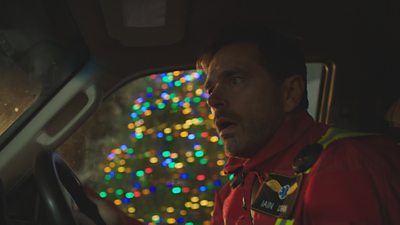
[196, 25, 308, 109]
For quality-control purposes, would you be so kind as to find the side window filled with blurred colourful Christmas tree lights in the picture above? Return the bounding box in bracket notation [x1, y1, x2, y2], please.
[59, 70, 228, 224]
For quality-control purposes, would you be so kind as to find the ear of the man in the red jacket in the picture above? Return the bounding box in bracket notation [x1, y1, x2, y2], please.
[282, 75, 305, 112]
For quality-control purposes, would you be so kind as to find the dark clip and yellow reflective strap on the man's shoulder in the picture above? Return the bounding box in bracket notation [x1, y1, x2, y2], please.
[292, 128, 376, 174]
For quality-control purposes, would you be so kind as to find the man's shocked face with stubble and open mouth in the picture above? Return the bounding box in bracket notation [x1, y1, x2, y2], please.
[205, 44, 284, 158]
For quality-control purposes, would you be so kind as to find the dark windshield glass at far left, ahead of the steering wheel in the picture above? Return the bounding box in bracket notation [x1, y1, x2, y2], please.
[0, 0, 88, 144]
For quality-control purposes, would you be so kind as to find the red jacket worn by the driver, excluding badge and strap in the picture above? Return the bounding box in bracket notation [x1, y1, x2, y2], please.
[212, 112, 400, 225]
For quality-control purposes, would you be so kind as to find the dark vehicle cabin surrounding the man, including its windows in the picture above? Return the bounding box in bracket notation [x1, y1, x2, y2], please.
[0, 0, 400, 225]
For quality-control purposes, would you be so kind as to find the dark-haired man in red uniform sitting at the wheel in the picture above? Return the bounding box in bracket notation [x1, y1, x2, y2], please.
[199, 28, 400, 225]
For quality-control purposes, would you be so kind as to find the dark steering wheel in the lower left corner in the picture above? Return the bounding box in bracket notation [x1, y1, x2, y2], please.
[35, 151, 106, 225]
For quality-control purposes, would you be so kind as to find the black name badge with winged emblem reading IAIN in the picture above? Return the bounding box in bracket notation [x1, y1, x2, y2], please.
[251, 174, 303, 219]
